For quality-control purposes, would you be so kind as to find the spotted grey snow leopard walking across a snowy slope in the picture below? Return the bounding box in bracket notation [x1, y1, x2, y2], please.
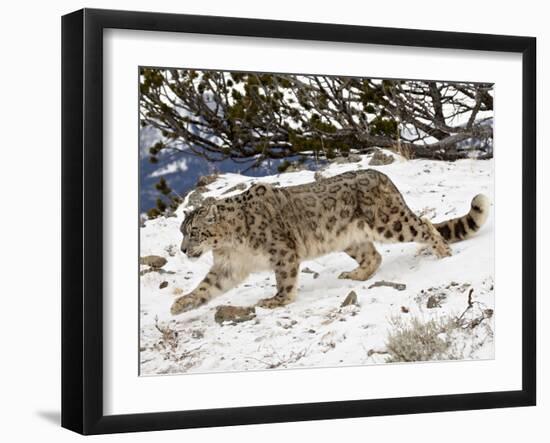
[170, 169, 490, 315]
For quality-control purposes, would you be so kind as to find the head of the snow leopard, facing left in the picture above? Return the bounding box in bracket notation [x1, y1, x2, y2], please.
[180, 203, 224, 258]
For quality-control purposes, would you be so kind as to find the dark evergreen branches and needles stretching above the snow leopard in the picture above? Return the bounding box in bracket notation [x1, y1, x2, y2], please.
[140, 68, 493, 166]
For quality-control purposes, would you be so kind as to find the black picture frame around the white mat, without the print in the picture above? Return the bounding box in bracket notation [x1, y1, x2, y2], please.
[62, 9, 536, 434]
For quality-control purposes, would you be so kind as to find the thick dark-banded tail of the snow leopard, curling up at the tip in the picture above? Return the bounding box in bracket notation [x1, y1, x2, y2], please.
[433, 194, 490, 243]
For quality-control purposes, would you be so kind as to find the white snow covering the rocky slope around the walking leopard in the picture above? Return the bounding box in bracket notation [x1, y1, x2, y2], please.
[140, 154, 494, 375]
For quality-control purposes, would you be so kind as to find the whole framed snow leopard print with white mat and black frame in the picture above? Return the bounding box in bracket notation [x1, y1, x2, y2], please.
[62, 9, 536, 434]
